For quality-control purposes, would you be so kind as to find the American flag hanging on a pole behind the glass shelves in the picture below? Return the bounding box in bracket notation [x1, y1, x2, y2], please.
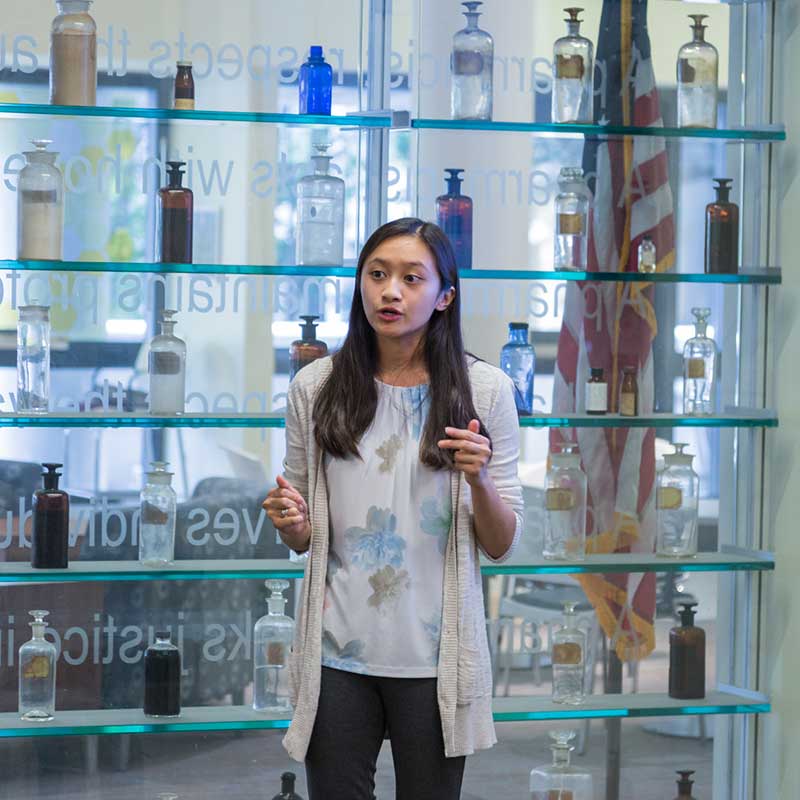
[550, 0, 675, 661]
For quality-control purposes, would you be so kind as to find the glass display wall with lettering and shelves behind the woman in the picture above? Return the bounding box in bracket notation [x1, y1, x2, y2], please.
[0, 0, 785, 800]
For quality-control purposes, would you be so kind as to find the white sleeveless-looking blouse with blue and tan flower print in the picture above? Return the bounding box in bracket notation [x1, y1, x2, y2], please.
[322, 381, 452, 678]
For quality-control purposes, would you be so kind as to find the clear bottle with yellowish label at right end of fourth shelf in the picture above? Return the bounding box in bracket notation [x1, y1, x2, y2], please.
[656, 442, 700, 558]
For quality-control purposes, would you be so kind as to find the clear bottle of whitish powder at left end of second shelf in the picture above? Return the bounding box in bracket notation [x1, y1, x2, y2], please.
[17, 139, 64, 261]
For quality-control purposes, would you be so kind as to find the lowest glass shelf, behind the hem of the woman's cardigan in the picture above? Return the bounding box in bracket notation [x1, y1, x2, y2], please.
[0, 687, 770, 738]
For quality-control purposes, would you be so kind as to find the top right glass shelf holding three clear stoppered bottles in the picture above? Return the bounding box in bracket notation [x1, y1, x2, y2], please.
[411, 117, 786, 142]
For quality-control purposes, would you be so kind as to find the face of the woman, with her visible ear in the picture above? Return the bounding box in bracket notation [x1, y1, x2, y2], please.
[361, 235, 455, 340]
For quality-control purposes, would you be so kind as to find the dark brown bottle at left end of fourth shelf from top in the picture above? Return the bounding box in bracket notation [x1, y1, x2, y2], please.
[31, 464, 69, 569]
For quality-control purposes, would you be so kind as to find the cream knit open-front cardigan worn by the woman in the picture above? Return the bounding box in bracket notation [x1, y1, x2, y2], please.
[283, 357, 523, 761]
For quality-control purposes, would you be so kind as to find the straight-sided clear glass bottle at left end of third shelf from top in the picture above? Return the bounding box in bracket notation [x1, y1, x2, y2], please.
[17, 306, 50, 414]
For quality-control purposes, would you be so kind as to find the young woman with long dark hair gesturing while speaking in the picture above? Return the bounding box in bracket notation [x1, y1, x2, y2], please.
[264, 219, 522, 800]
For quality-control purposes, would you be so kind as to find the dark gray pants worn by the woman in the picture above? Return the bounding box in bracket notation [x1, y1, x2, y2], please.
[306, 667, 466, 800]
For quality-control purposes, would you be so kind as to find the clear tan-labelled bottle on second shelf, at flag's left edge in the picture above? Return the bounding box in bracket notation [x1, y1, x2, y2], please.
[555, 167, 591, 270]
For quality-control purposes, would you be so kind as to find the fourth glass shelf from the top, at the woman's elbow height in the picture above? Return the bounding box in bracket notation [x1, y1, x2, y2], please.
[0, 551, 775, 584]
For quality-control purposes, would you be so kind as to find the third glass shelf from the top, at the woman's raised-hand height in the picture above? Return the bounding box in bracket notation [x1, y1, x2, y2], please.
[0, 409, 778, 428]
